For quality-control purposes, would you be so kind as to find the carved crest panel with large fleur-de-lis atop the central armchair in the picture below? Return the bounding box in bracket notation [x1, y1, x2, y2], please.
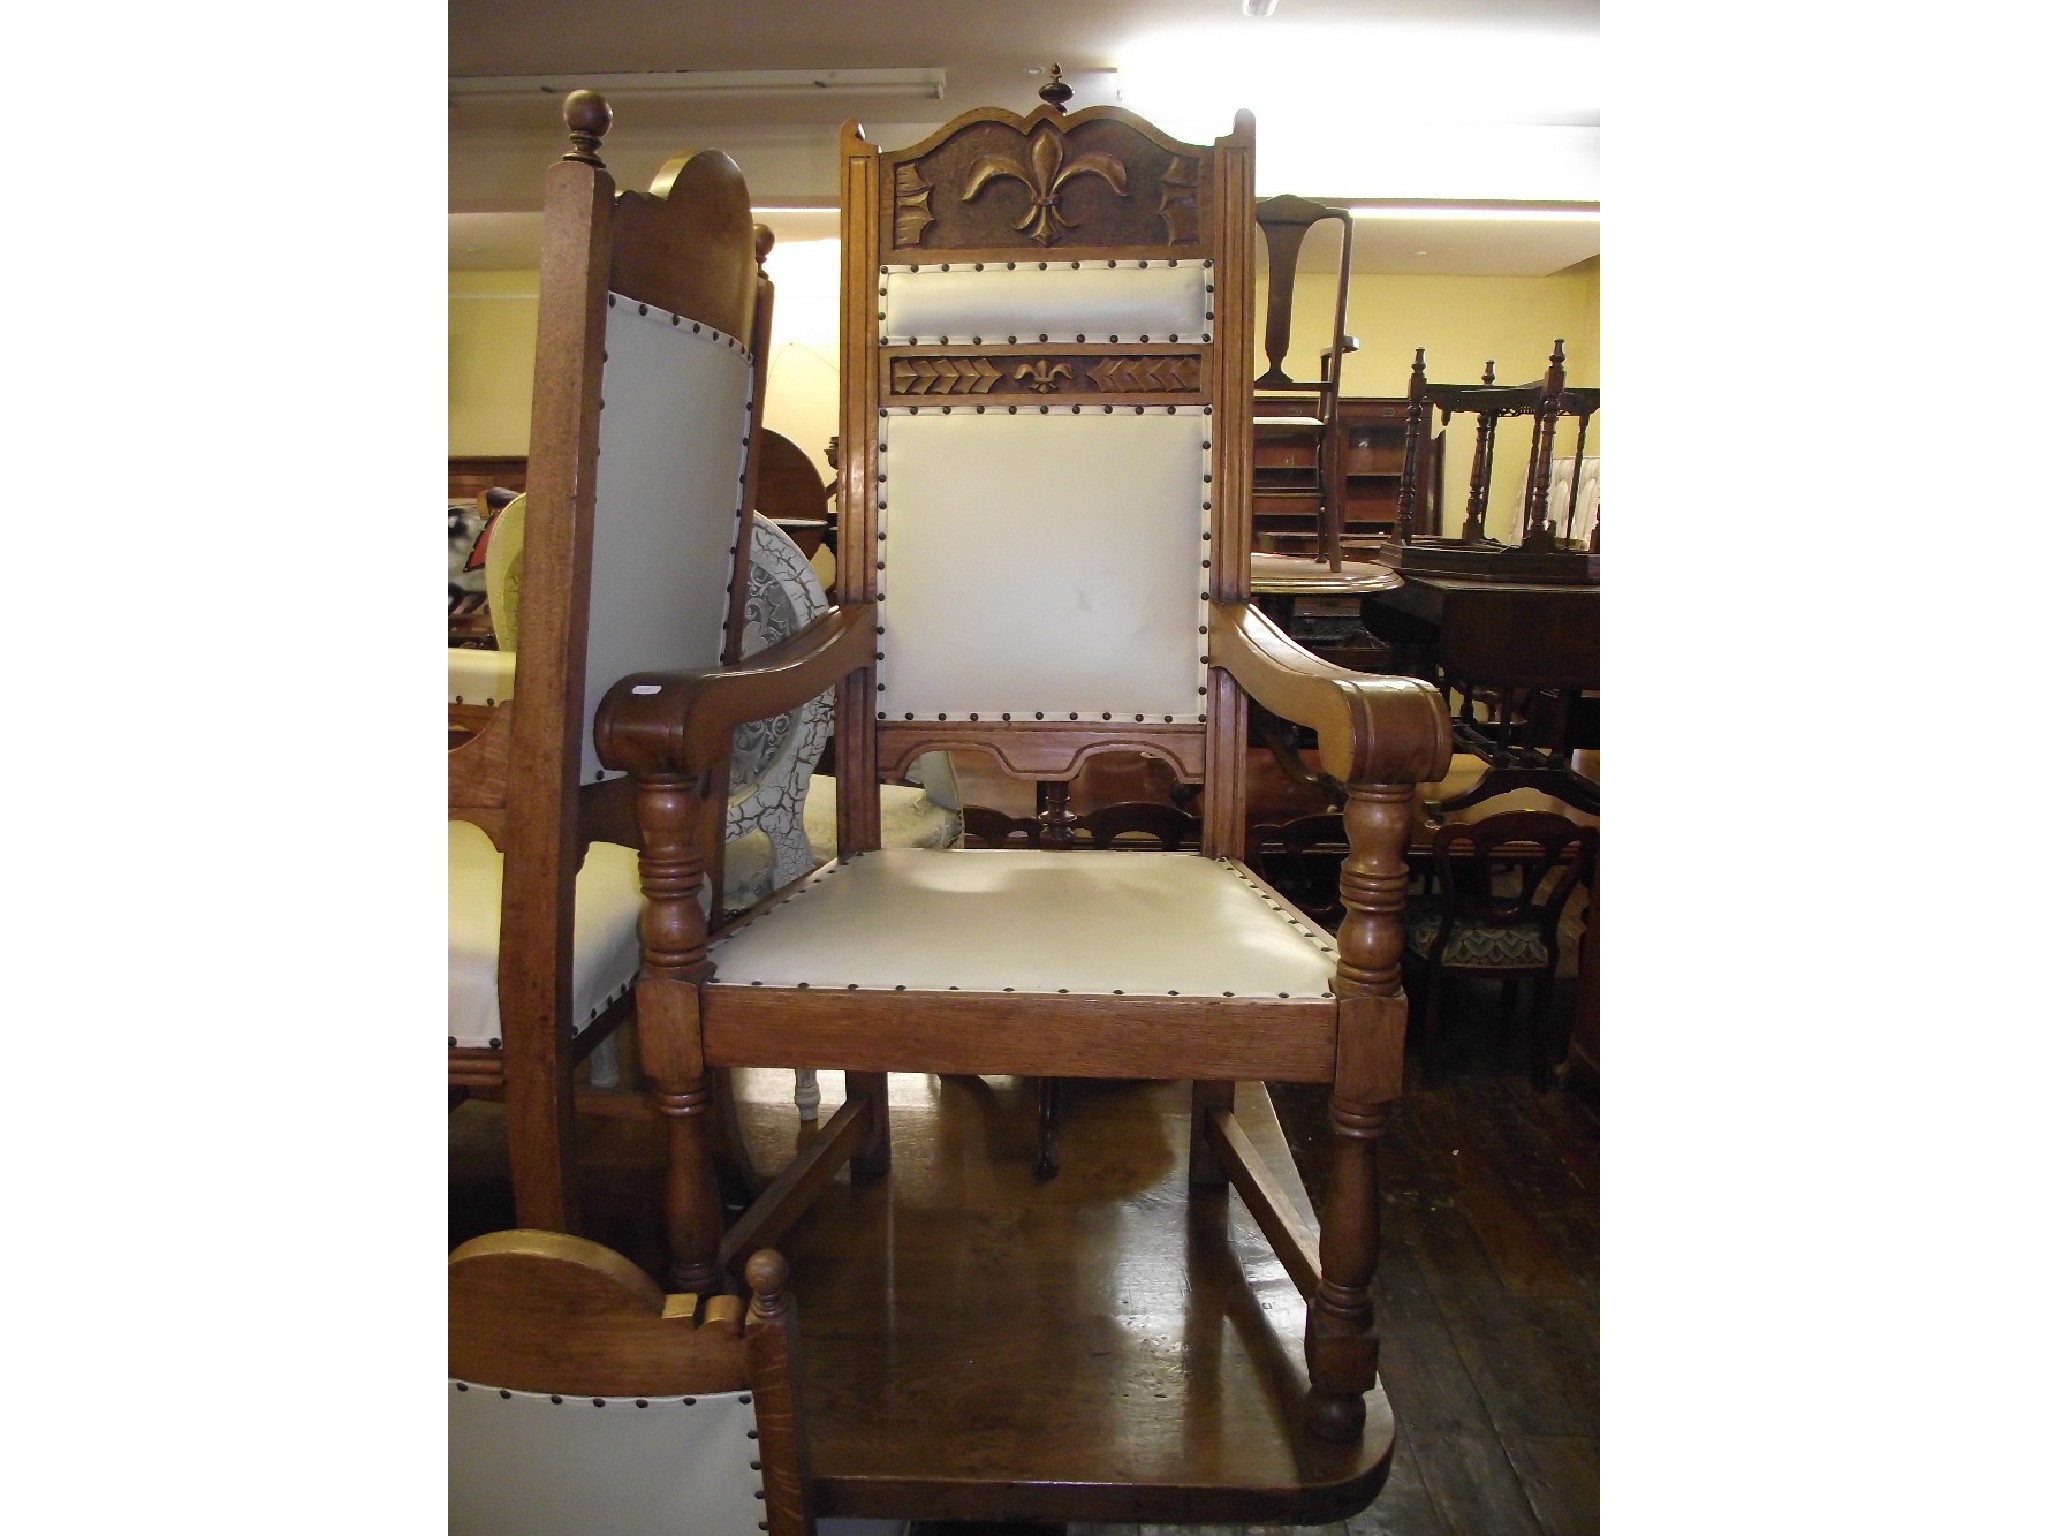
[887, 113, 1212, 252]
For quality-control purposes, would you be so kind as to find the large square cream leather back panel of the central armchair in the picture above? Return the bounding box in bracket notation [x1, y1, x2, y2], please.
[877, 406, 1210, 723]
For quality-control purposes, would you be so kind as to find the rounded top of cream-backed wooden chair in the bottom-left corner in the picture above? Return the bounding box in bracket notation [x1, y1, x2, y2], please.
[449, 1231, 892, 1536]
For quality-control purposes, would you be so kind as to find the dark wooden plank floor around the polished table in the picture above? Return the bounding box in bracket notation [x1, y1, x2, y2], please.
[451, 979, 1599, 1536]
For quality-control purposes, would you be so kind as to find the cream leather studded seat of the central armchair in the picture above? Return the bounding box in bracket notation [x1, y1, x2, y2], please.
[711, 848, 1335, 997]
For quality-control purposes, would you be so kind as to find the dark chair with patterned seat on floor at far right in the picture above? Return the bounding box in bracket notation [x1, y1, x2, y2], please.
[1405, 811, 1599, 1087]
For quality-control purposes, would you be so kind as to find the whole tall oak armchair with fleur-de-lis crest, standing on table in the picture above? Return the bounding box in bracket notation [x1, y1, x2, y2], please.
[598, 106, 1450, 1444]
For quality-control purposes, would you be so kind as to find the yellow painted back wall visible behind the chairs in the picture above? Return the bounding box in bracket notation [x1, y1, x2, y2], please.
[449, 252, 1599, 537]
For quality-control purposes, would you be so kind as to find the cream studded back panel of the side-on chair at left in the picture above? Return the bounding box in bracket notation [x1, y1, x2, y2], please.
[580, 295, 754, 784]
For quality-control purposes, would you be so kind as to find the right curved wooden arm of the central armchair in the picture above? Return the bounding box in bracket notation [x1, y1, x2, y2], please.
[1208, 602, 1450, 786]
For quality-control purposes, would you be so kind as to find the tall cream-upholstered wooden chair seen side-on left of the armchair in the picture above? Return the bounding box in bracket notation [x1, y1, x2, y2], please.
[449, 92, 770, 1231]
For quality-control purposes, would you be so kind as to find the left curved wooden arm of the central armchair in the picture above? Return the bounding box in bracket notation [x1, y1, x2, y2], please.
[594, 602, 874, 778]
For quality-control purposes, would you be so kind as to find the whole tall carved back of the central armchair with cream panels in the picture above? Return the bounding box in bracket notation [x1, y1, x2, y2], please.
[836, 104, 1253, 868]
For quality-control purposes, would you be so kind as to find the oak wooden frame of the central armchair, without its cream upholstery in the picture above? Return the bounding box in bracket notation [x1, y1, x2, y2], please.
[598, 106, 1450, 1442]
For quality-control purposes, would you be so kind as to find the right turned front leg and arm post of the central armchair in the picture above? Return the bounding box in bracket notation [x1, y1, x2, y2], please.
[1307, 784, 1411, 1442]
